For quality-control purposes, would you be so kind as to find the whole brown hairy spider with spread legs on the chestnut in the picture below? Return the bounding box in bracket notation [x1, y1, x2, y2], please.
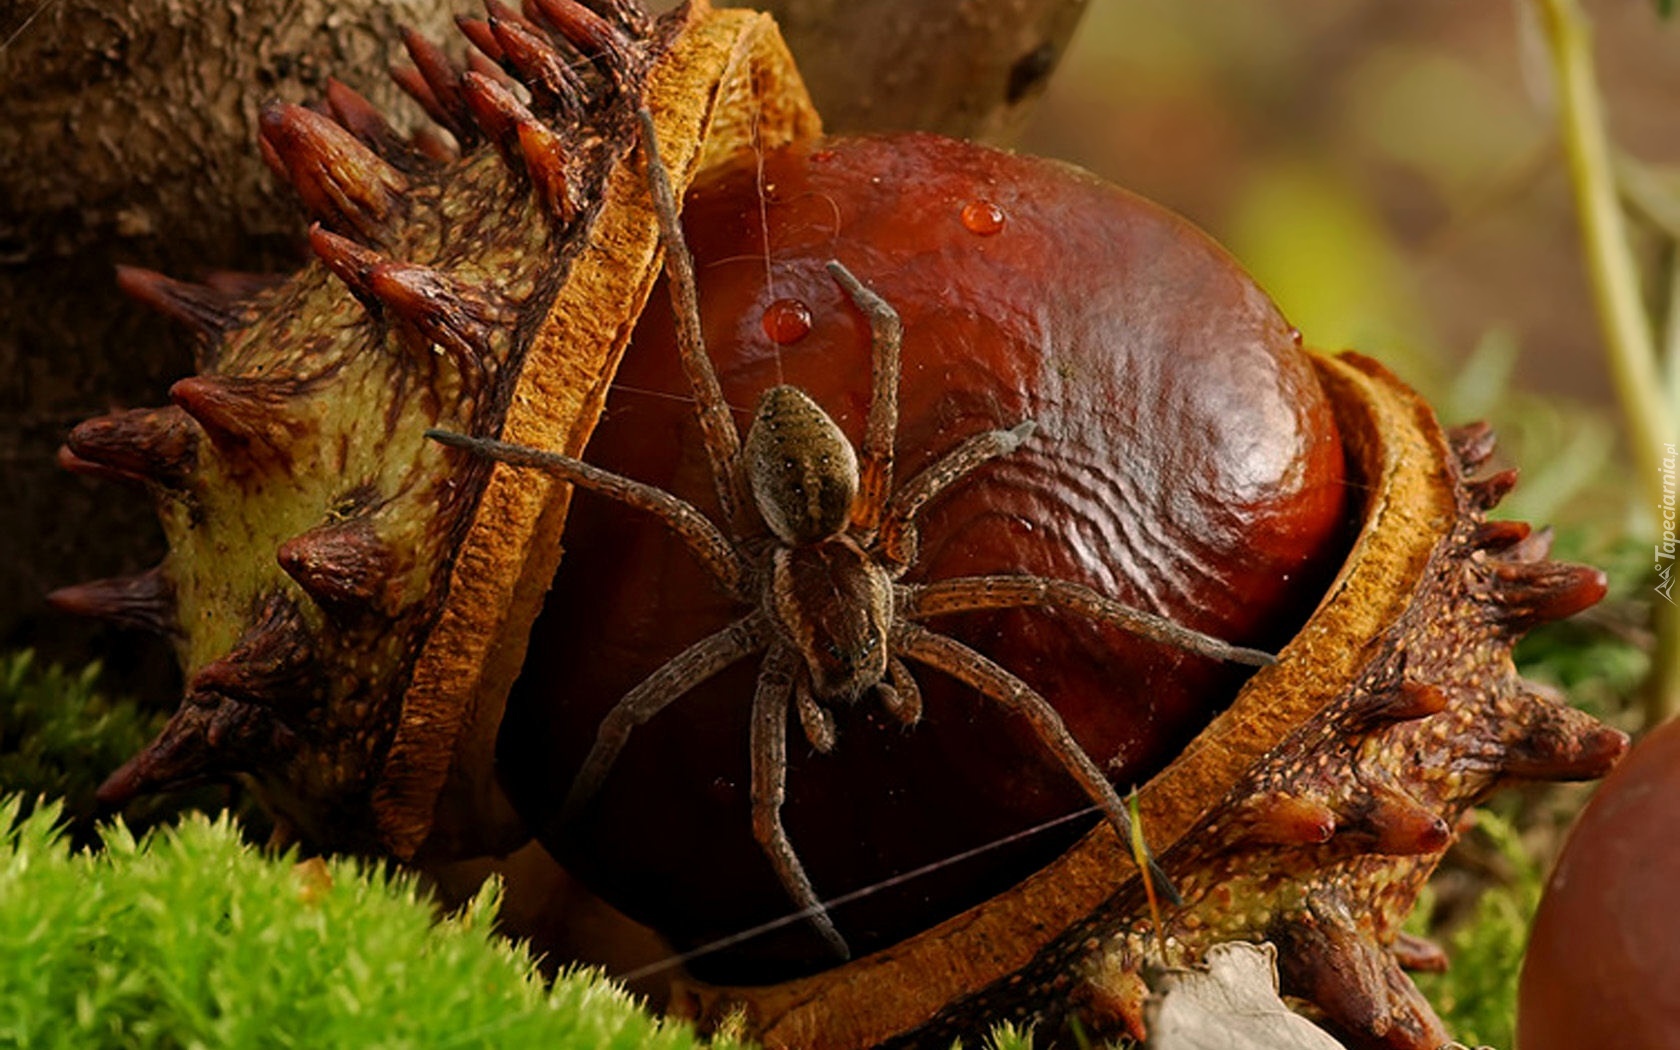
[427, 109, 1273, 958]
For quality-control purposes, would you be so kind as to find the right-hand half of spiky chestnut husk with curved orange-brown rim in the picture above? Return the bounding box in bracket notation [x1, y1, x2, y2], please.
[677, 354, 1626, 1050]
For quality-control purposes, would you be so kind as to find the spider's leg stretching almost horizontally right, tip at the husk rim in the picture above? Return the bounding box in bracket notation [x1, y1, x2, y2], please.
[894, 576, 1277, 667]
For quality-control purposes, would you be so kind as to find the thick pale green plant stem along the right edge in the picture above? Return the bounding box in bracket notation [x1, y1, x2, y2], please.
[1536, 0, 1680, 726]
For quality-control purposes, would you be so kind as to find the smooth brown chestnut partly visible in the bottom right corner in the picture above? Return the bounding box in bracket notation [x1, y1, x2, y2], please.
[1517, 708, 1680, 1050]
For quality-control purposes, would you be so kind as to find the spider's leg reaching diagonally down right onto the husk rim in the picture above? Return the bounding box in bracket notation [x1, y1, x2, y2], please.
[895, 622, 1183, 904]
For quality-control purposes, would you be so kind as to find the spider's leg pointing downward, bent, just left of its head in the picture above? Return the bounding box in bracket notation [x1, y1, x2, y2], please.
[753, 643, 852, 959]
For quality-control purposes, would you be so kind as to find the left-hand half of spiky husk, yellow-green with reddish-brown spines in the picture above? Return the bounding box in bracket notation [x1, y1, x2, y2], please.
[54, 0, 818, 857]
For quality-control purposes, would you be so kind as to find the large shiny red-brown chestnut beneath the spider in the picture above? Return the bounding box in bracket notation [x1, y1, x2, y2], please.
[499, 136, 1346, 983]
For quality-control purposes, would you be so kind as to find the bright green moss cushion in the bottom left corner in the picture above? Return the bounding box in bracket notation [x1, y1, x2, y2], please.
[0, 796, 735, 1050]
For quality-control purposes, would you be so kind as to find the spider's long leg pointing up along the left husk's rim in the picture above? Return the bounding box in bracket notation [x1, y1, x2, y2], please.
[637, 108, 741, 526]
